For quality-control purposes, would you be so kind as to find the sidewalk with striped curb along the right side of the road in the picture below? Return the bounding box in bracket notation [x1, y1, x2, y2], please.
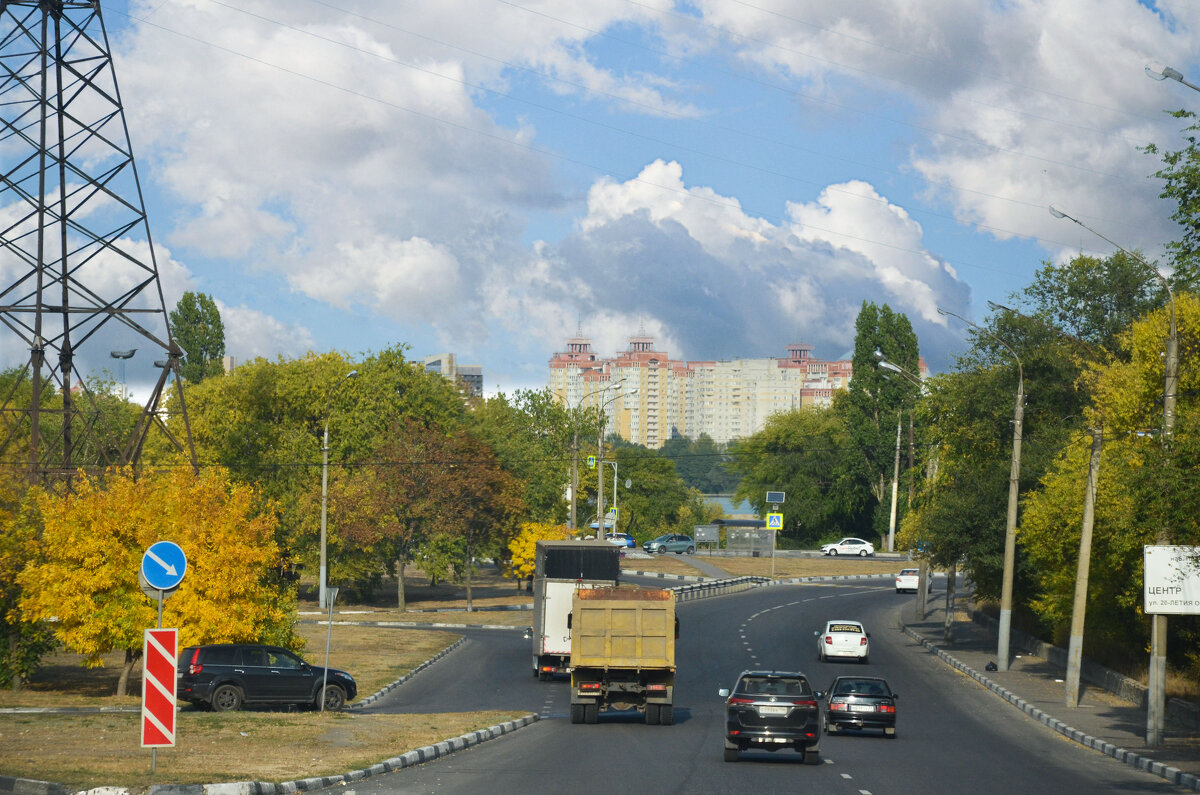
[898, 598, 1200, 791]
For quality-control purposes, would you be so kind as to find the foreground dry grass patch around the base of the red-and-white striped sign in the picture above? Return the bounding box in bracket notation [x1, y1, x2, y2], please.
[0, 711, 523, 791]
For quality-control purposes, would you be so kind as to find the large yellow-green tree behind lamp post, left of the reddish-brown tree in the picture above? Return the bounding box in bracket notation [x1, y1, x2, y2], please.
[173, 346, 467, 582]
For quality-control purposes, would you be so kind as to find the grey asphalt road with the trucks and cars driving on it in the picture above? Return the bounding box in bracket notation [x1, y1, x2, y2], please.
[330, 581, 1180, 795]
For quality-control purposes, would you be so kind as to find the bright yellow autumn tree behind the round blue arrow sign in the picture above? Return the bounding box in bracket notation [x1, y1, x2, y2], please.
[18, 467, 295, 695]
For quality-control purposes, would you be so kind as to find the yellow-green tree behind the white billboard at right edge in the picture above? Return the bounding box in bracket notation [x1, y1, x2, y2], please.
[1021, 293, 1200, 674]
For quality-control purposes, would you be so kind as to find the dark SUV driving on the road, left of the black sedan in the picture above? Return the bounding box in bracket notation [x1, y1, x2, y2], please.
[718, 671, 823, 765]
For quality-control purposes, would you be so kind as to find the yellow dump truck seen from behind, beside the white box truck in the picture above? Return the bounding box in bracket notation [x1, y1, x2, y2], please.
[571, 586, 679, 725]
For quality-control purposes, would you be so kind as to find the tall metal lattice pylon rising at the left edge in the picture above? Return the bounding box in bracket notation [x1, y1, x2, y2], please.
[0, 0, 196, 480]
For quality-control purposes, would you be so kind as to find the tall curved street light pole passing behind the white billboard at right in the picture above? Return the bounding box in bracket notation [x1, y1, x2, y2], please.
[1050, 205, 1176, 748]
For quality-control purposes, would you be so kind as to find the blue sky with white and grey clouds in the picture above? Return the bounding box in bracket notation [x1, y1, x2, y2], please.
[7, 0, 1200, 394]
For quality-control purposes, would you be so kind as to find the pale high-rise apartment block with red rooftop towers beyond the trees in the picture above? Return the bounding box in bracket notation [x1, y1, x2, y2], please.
[550, 334, 897, 449]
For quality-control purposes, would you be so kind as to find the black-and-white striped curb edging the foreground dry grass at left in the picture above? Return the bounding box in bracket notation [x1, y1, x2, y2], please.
[145, 712, 539, 795]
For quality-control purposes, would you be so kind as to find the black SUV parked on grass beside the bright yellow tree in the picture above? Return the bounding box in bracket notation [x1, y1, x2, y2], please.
[175, 644, 359, 712]
